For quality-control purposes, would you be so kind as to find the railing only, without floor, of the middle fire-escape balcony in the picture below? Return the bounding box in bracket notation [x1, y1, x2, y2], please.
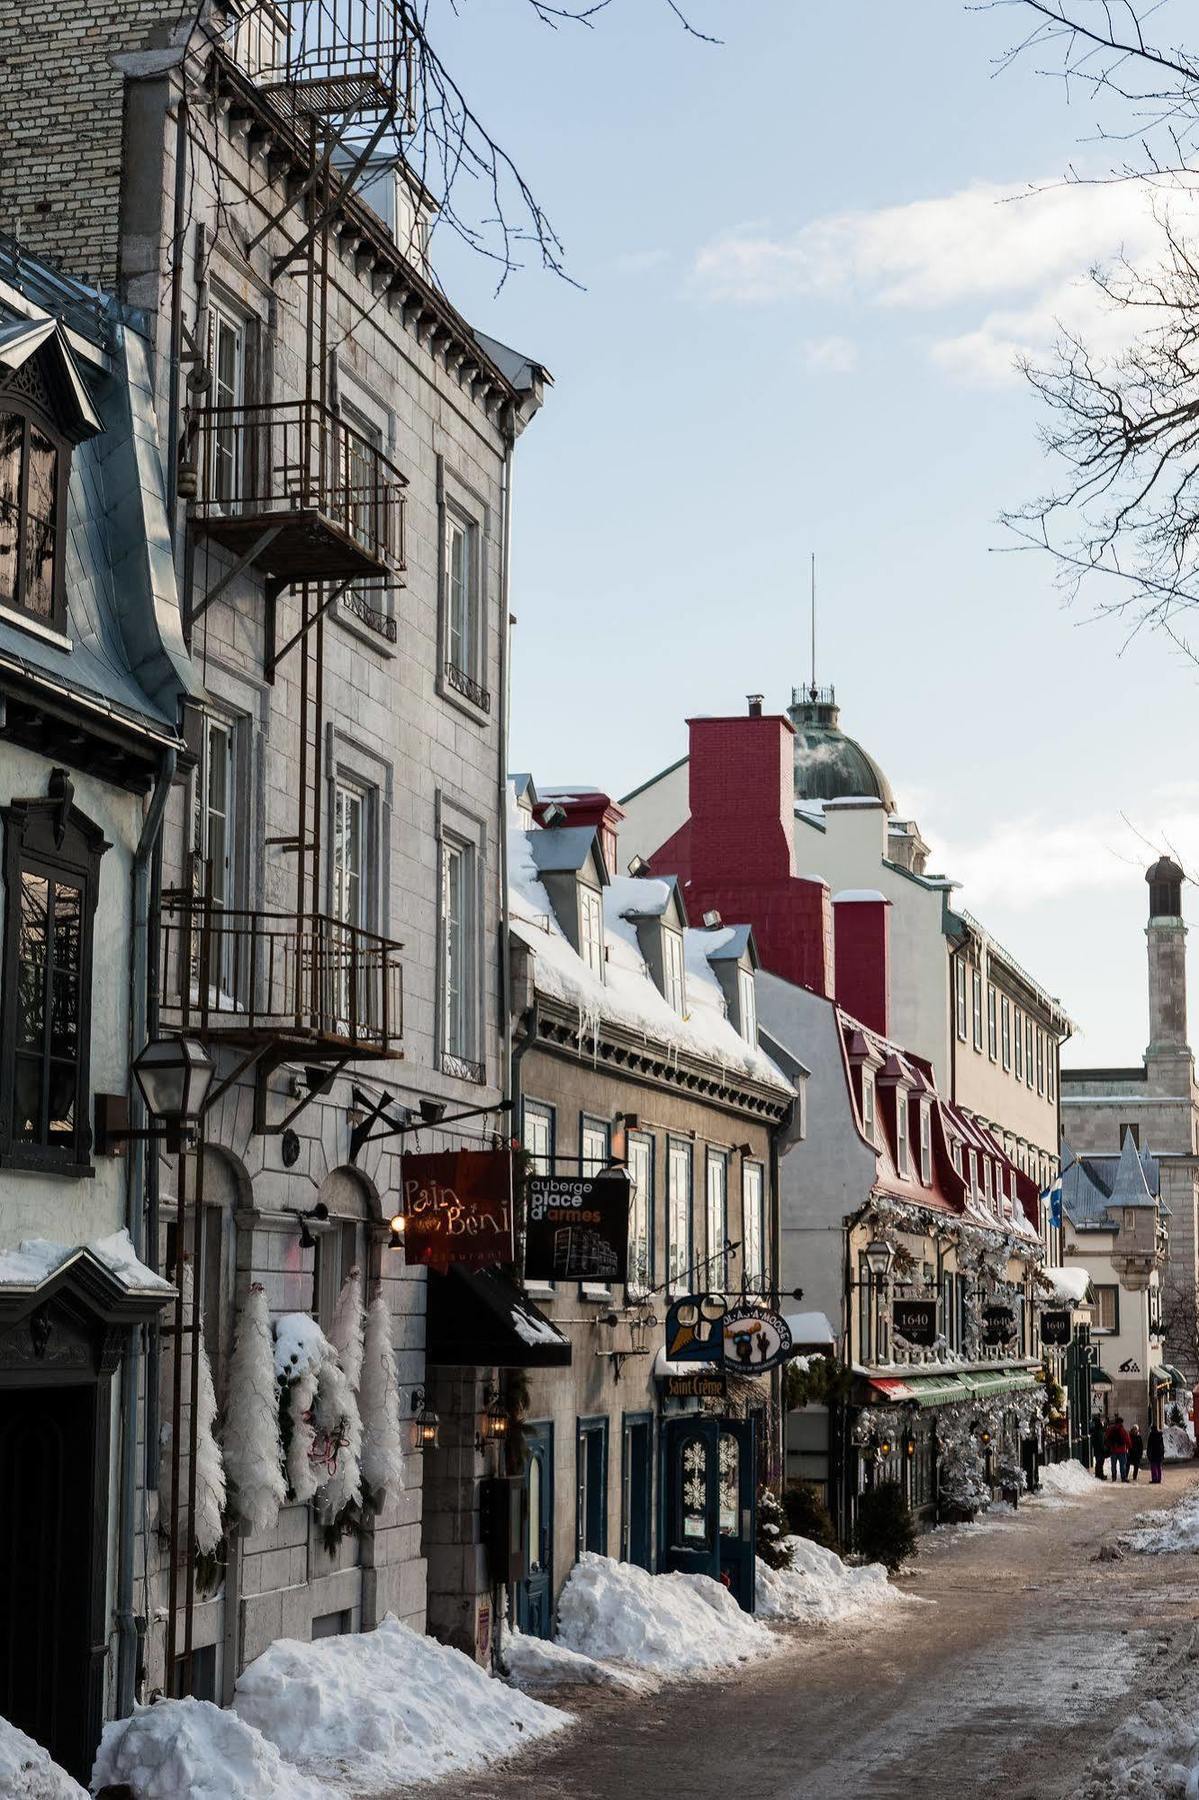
[194, 400, 407, 572]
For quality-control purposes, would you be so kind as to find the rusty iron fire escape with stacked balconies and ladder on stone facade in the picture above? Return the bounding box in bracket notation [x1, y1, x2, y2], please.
[162, 0, 409, 1108]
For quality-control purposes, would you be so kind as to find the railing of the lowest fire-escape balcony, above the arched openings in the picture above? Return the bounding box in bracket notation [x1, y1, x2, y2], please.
[160, 891, 403, 1057]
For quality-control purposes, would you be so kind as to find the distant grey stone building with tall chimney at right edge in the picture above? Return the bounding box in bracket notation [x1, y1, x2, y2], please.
[1062, 857, 1199, 1381]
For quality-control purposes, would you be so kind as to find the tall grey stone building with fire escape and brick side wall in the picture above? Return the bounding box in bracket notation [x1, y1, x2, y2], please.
[0, 0, 545, 1742]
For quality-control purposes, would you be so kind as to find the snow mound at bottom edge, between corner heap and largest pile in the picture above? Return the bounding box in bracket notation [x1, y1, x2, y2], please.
[92, 1699, 328, 1800]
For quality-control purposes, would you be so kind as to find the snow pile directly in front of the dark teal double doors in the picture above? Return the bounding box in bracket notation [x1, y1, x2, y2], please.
[558, 1552, 780, 1676]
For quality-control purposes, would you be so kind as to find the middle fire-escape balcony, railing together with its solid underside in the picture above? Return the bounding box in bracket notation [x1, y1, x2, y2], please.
[194, 400, 407, 581]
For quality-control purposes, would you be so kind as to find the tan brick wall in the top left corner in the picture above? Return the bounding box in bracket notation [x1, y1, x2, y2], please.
[0, 0, 180, 286]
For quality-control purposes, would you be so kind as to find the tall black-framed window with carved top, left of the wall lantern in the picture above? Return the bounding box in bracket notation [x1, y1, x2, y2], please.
[0, 784, 106, 1168]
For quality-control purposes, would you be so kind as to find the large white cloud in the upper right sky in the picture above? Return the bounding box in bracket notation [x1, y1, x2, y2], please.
[693, 182, 1199, 383]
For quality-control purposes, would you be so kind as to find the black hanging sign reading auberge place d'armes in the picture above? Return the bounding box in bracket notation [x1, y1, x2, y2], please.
[524, 1172, 628, 1282]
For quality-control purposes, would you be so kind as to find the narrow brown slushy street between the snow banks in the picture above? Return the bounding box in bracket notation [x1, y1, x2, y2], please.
[427, 1467, 1199, 1800]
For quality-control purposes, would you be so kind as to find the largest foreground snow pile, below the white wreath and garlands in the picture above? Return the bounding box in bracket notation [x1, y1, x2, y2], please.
[234, 1618, 571, 1795]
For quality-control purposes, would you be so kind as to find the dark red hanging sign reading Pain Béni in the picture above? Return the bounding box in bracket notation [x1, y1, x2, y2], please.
[401, 1150, 513, 1271]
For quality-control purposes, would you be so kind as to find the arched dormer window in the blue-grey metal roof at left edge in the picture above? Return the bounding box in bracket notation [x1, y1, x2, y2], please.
[0, 398, 70, 628]
